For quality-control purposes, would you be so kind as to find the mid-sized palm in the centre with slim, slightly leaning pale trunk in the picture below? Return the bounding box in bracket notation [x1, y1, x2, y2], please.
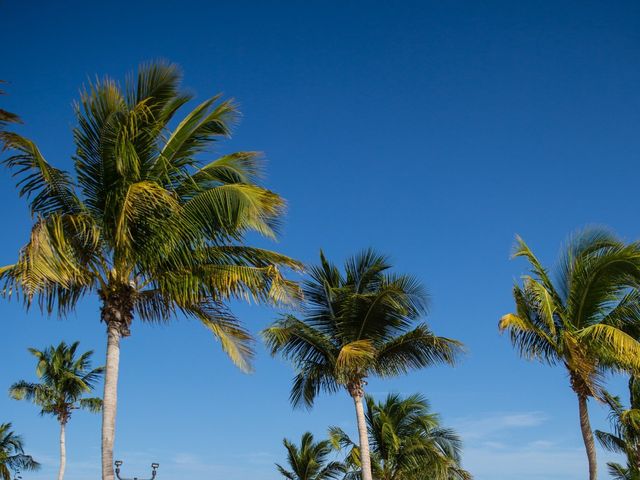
[263, 250, 461, 480]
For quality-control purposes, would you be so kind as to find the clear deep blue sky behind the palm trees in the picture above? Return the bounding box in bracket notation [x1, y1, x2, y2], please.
[0, 0, 640, 480]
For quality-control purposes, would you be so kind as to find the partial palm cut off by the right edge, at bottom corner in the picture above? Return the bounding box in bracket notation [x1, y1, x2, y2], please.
[596, 375, 640, 480]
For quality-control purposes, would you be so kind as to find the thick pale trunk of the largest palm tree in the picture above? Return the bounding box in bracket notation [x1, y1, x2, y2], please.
[102, 323, 120, 480]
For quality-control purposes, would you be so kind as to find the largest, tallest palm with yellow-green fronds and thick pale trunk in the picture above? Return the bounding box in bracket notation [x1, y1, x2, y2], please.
[0, 62, 299, 480]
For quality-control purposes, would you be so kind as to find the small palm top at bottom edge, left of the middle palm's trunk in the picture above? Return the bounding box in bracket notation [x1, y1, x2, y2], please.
[276, 432, 345, 480]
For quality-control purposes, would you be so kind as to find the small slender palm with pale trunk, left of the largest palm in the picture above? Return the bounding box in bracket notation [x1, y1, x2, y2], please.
[9, 342, 104, 480]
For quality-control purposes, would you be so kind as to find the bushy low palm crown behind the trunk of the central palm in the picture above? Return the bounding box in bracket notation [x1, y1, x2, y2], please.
[329, 394, 472, 480]
